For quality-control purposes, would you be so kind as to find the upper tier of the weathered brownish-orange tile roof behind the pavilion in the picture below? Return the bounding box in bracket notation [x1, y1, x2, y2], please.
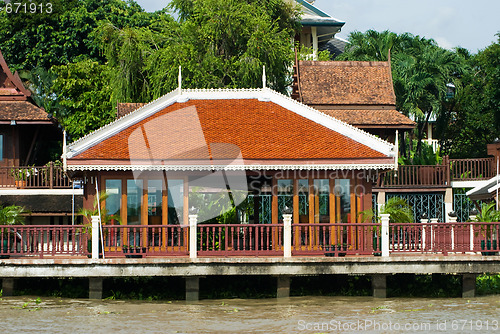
[299, 61, 396, 105]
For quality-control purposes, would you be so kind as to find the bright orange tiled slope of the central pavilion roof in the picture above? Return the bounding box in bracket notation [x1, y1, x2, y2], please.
[71, 98, 387, 161]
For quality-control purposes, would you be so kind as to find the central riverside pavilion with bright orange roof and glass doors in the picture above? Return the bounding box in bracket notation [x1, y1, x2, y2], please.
[65, 88, 396, 253]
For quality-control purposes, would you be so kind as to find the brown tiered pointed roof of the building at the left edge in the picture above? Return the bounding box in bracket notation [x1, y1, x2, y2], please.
[0, 51, 52, 123]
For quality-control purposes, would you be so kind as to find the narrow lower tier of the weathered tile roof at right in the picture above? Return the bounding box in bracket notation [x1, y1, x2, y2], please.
[320, 109, 415, 128]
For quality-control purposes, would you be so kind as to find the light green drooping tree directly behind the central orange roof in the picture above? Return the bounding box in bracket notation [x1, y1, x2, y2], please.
[98, 0, 299, 102]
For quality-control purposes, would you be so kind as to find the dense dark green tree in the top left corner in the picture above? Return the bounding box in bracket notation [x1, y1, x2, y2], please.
[0, 0, 159, 70]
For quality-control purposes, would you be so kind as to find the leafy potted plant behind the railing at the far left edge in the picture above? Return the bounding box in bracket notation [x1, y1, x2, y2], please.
[0, 205, 28, 259]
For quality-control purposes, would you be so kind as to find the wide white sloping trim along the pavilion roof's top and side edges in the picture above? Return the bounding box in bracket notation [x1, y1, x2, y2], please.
[67, 88, 395, 159]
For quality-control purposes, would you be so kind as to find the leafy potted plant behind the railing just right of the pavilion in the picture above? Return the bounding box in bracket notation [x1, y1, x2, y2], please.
[359, 196, 413, 256]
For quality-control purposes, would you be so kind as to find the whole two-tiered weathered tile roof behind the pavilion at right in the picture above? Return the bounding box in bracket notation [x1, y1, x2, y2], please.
[292, 61, 415, 129]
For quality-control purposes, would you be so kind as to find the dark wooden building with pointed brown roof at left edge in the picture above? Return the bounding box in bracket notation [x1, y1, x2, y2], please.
[0, 52, 81, 224]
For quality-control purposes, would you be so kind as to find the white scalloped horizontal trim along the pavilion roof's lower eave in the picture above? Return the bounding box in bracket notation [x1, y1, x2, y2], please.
[68, 164, 394, 171]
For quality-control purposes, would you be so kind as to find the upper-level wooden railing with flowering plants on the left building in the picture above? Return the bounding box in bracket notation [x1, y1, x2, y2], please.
[0, 162, 71, 189]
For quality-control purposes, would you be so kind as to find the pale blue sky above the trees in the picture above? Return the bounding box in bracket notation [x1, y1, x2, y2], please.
[136, 0, 500, 53]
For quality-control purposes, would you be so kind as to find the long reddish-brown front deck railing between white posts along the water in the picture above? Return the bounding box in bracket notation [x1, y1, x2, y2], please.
[0, 222, 500, 258]
